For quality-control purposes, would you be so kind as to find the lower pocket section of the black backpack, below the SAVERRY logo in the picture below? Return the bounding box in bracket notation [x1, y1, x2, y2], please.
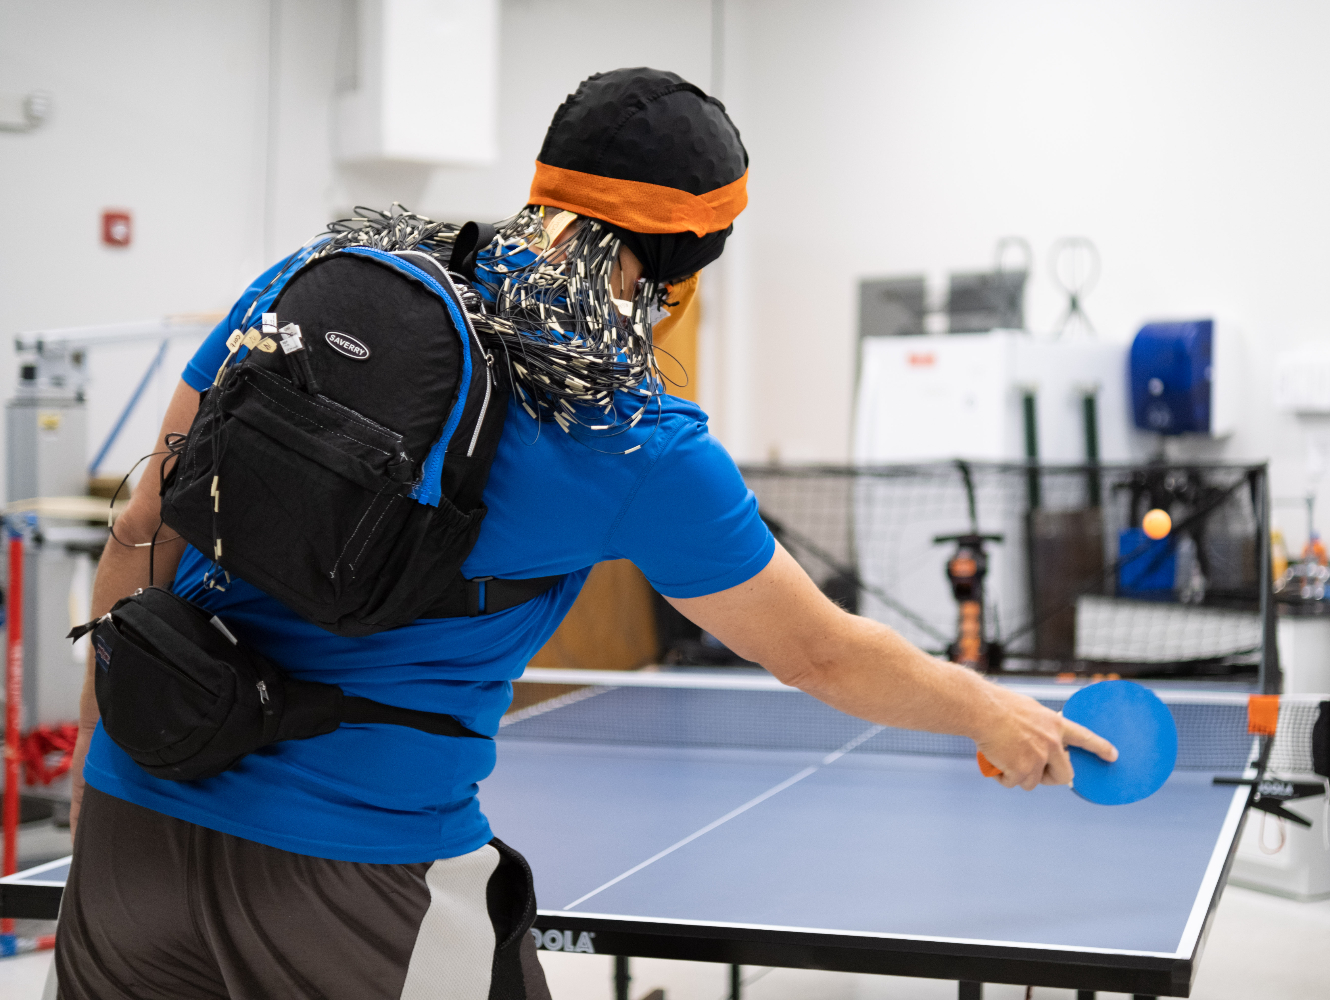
[162, 366, 484, 636]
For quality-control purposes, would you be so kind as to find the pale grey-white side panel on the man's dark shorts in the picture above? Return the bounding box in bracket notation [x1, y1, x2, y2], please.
[402, 844, 499, 1000]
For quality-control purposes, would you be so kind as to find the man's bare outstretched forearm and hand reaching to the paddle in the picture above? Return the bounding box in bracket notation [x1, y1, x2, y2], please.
[669, 544, 1117, 789]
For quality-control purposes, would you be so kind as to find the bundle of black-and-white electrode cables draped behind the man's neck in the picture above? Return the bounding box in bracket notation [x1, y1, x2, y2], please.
[303, 203, 666, 453]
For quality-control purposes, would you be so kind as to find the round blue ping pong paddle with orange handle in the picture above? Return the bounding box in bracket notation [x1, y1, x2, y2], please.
[979, 681, 1177, 806]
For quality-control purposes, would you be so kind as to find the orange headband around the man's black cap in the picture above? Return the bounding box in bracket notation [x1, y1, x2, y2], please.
[527, 160, 747, 237]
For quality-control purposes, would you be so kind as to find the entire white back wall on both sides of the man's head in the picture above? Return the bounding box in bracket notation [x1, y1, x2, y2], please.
[0, 0, 1330, 542]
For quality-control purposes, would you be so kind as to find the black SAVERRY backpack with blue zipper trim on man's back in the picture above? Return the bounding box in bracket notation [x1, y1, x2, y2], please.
[162, 240, 561, 636]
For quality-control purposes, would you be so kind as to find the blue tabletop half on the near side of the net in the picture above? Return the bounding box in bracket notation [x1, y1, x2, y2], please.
[480, 737, 1234, 953]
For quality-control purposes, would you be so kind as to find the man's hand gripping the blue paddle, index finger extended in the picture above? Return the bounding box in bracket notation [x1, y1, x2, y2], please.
[970, 685, 1117, 791]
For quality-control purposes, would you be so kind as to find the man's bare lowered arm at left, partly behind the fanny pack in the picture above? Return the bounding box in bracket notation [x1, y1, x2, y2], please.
[69, 382, 198, 831]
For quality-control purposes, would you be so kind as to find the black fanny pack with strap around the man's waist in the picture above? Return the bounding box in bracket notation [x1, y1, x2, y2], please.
[69, 586, 489, 781]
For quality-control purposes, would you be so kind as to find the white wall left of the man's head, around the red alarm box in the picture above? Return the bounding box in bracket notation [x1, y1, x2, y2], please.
[0, 0, 710, 495]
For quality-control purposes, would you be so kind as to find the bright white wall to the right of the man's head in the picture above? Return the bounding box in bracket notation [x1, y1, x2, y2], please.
[726, 0, 1330, 539]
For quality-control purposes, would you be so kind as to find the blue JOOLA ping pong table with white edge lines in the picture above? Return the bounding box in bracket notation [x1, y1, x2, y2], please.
[0, 669, 1287, 1000]
